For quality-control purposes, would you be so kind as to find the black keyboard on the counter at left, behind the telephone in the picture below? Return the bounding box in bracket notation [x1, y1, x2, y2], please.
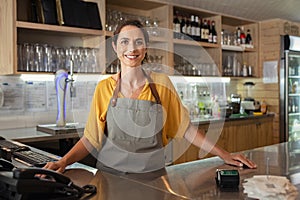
[13, 150, 57, 167]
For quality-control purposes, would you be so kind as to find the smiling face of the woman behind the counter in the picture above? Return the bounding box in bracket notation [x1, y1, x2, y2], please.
[113, 25, 147, 67]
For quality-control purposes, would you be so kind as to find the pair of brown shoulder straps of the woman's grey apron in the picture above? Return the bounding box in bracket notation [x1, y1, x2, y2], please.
[111, 69, 161, 106]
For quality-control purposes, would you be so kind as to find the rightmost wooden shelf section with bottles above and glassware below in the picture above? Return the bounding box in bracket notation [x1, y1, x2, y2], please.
[221, 16, 260, 78]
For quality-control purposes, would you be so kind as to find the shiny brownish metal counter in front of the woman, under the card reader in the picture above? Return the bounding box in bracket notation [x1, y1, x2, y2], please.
[65, 143, 300, 200]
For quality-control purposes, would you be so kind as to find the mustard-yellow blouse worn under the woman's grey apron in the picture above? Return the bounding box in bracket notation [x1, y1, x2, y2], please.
[84, 72, 190, 149]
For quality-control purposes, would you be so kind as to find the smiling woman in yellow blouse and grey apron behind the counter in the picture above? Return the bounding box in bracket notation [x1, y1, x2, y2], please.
[45, 20, 256, 173]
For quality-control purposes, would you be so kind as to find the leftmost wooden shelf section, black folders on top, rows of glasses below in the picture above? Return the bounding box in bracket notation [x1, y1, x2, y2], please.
[0, 0, 105, 74]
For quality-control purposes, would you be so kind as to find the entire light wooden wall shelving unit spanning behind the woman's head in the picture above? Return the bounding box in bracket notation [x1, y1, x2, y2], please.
[0, 0, 259, 77]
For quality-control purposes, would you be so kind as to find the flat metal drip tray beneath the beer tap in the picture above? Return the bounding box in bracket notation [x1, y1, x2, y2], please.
[36, 123, 84, 135]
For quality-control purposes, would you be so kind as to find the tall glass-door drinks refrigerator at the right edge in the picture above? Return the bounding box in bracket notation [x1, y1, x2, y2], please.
[280, 35, 300, 173]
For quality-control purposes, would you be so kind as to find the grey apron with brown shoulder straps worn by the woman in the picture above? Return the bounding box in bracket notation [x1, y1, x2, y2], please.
[97, 72, 165, 173]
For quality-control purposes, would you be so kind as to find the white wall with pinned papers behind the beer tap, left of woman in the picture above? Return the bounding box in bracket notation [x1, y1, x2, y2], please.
[0, 75, 99, 130]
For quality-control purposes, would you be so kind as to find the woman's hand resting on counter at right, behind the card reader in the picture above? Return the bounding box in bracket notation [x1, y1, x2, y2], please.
[222, 153, 257, 169]
